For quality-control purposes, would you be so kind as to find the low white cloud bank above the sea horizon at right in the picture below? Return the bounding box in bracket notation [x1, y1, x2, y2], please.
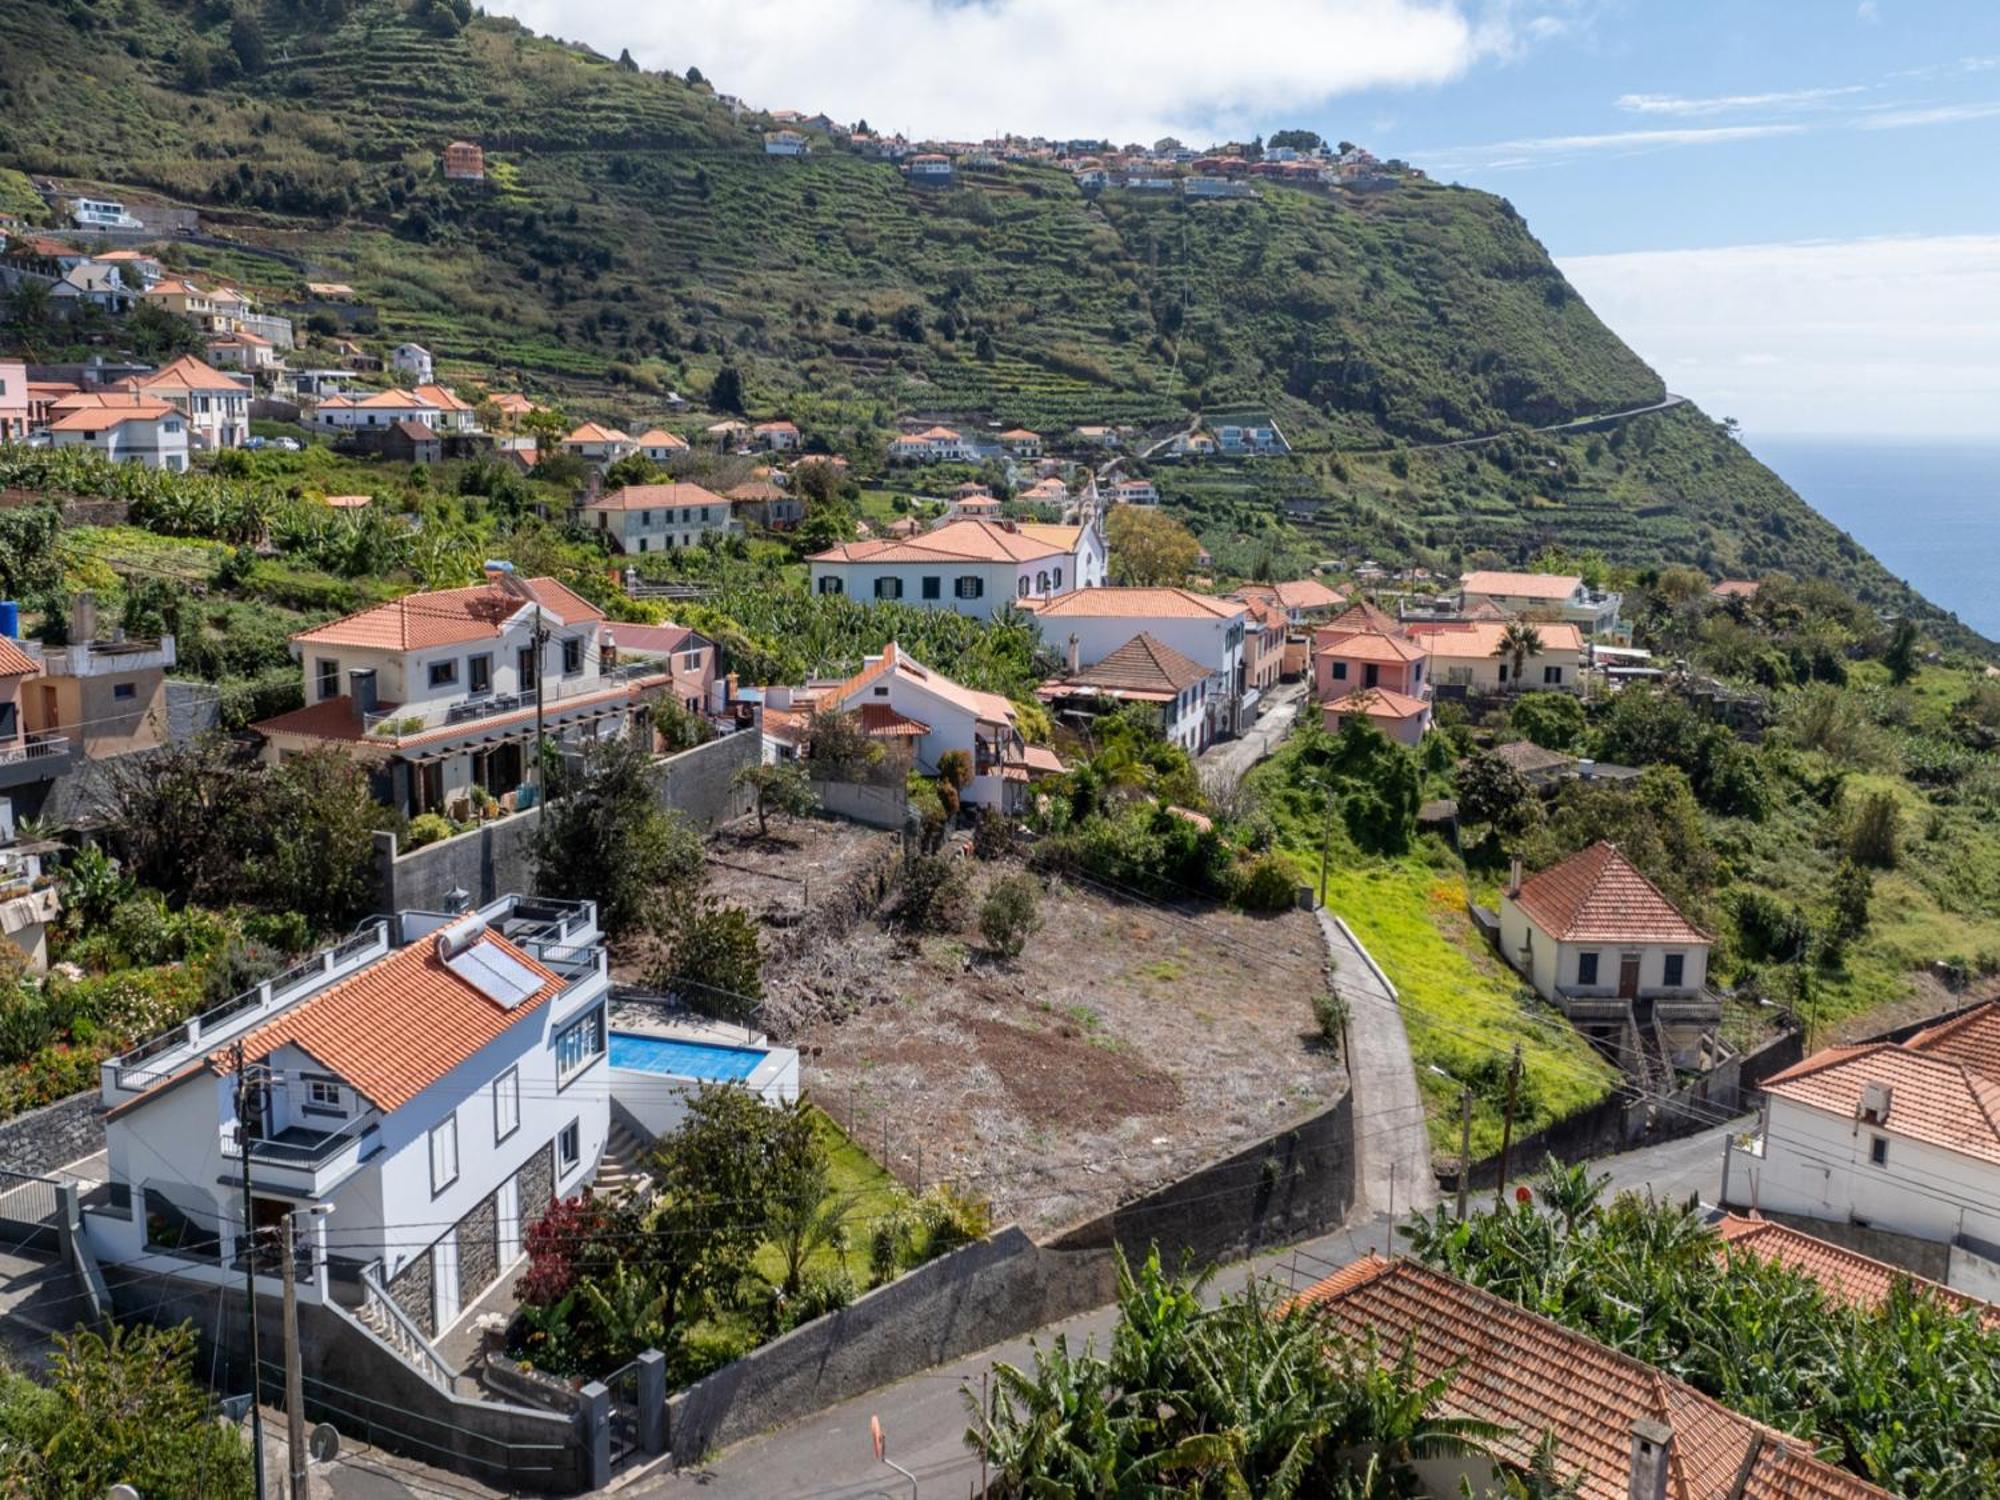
[1560, 234, 2000, 438]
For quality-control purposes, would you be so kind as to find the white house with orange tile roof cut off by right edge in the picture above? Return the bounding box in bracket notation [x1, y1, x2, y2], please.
[1722, 1002, 2000, 1300]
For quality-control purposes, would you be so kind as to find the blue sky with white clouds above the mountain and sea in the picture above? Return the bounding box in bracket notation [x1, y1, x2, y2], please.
[486, 0, 2000, 440]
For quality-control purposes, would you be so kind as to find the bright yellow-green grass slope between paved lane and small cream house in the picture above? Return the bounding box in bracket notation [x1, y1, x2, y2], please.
[1306, 856, 1618, 1158]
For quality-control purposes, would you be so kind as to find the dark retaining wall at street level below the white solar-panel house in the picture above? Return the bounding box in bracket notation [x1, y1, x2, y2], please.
[104, 1266, 588, 1494]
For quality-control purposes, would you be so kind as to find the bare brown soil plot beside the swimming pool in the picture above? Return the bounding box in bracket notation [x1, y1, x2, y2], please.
[784, 860, 1346, 1230]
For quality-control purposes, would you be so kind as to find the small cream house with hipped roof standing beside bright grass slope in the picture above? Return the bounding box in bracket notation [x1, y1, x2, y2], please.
[1500, 840, 1722, 1066]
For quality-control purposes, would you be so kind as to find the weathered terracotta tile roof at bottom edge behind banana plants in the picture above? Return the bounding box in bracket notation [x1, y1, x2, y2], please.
[1298, 1252, 1888, 1500]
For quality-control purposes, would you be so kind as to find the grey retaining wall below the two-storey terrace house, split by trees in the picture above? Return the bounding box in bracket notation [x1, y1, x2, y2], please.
[376, 732, 762, 912]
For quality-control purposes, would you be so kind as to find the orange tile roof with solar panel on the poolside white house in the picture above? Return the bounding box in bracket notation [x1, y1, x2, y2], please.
[219, 932, 564, 1112]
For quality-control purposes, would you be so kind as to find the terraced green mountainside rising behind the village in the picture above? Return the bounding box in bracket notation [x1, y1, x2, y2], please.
[0, 0, 1966, 638]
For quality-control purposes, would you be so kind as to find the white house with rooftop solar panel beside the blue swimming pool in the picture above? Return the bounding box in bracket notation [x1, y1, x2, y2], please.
[86, 896, 610, 1340]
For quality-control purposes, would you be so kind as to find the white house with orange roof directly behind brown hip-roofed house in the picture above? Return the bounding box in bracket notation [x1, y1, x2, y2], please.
[1024, 586, 1248, 746]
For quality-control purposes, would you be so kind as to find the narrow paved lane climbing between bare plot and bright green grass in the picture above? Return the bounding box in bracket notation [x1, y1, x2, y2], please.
[1318, 906, 1438, 1216]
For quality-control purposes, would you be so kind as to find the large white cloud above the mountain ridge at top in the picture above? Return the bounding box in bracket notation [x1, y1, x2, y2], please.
[488, 0, 1524, 140]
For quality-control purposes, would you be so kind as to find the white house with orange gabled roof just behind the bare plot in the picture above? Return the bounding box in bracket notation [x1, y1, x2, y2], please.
[814, 640, 1060, 812]
